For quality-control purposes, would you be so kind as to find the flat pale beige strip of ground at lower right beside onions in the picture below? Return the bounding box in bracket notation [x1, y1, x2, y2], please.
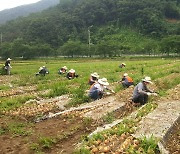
[135, 101, 180, 139]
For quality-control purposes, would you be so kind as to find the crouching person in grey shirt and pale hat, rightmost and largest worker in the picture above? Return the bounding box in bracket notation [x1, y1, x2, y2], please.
[132, 76, 157, 105]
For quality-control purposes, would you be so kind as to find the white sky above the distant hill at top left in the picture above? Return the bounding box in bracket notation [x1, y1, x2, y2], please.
[0, 0, 40, 11]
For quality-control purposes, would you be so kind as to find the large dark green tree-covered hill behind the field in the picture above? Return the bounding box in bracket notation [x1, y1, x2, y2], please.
[0, 0, 180, 58]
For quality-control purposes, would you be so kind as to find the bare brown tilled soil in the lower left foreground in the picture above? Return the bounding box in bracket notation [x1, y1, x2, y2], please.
[0, 115, 97, 154]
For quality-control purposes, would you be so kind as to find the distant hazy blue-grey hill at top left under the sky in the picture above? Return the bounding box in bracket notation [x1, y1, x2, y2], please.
[0, 0, 59, 24]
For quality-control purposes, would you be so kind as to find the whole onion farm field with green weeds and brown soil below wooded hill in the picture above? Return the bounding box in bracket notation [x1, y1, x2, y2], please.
[0, 59, 180, 154]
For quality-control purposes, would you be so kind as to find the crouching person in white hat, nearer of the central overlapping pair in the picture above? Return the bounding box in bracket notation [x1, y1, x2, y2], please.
[89, 78, 115, 100]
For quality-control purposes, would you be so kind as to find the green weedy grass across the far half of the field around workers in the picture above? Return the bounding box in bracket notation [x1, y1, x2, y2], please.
[0, 59, 180, 111]
